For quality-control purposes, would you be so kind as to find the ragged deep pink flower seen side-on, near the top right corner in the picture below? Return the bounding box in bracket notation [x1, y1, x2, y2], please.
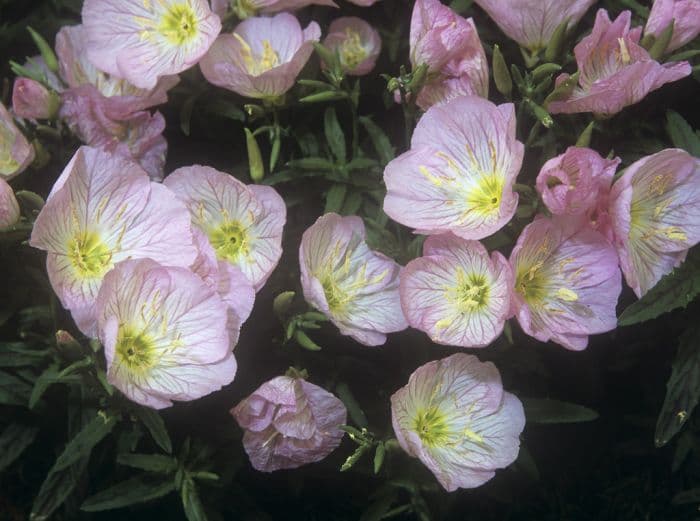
[548, 9, 691, 115]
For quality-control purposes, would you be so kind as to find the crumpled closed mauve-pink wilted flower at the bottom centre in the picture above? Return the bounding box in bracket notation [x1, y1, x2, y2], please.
[231, 376, 347, 472]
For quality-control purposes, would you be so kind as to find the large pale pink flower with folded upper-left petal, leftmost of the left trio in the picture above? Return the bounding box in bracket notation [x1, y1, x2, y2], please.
[29, 147, 197, 336]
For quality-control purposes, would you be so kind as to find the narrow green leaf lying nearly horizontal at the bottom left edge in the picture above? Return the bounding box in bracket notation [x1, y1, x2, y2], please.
[80, 475, 175, 512]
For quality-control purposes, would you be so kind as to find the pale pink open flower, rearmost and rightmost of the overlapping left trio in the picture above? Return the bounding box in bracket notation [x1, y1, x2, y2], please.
[163, 165, 287, 290]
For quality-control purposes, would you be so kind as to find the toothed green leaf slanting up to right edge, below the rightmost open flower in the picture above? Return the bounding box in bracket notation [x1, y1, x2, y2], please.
[618, 248, 700, 326]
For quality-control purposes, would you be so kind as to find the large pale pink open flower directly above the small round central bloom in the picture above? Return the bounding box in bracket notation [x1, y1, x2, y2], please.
[384, 96, 523, 239]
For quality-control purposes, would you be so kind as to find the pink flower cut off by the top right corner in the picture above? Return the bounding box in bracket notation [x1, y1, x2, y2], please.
[644, 0, 700, 52]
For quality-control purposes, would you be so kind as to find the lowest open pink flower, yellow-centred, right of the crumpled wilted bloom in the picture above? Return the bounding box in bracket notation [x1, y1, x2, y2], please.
[391, 353, 525, 492]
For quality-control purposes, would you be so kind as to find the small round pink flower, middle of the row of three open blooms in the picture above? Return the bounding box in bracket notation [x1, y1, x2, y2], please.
[400, 234, 513, 347]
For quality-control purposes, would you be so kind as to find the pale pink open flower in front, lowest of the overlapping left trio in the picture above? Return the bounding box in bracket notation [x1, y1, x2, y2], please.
[96, 258, 236, 409]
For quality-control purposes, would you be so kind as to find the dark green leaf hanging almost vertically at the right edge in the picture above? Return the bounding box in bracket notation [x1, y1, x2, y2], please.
[654, 326, 700, 447]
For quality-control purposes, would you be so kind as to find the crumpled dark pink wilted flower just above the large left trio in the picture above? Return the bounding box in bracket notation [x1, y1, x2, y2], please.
[59, 85, 168, 180]
